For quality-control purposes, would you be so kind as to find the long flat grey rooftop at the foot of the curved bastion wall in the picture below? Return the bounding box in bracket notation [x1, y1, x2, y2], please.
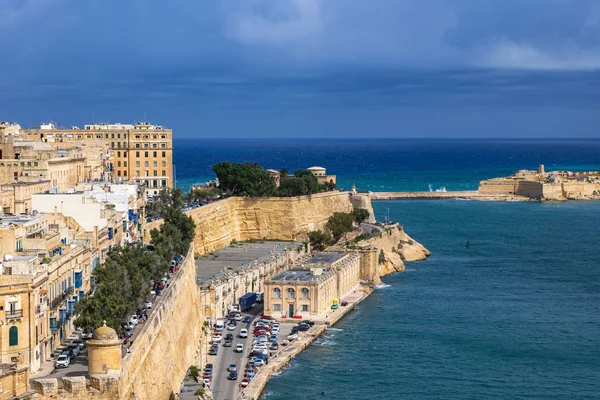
[196, 241, 304, 283]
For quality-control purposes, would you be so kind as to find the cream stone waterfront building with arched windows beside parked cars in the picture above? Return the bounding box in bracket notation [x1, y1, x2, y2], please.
[264, 253, 361, 318]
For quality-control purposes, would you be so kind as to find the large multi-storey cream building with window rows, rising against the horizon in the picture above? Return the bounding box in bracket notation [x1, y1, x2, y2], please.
[21, 122, 173, 196]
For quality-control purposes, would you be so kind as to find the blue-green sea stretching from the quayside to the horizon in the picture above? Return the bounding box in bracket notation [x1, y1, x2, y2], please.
[175, 139, 600, 400]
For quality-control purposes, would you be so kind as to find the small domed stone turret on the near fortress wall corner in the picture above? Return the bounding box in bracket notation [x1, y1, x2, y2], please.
[87, 321, 121, 375]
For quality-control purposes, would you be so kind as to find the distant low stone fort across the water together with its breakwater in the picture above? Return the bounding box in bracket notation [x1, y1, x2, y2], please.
[369, 165, 600, 201]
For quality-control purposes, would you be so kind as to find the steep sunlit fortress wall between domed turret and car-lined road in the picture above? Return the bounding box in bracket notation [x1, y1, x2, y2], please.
[118, 247, 209, 400]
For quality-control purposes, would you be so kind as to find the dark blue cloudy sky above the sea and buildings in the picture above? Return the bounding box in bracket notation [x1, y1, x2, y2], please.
[0, 0, 600, 138]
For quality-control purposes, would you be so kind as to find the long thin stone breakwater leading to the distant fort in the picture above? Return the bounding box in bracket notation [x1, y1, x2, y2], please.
[369, 190, 530, 201]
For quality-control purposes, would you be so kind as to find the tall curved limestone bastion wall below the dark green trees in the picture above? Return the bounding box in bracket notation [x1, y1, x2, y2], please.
[144, 192, 356, 256]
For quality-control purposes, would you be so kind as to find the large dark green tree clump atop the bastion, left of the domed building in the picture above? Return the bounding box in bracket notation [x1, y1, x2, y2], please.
[213, 162, 276, 197]
